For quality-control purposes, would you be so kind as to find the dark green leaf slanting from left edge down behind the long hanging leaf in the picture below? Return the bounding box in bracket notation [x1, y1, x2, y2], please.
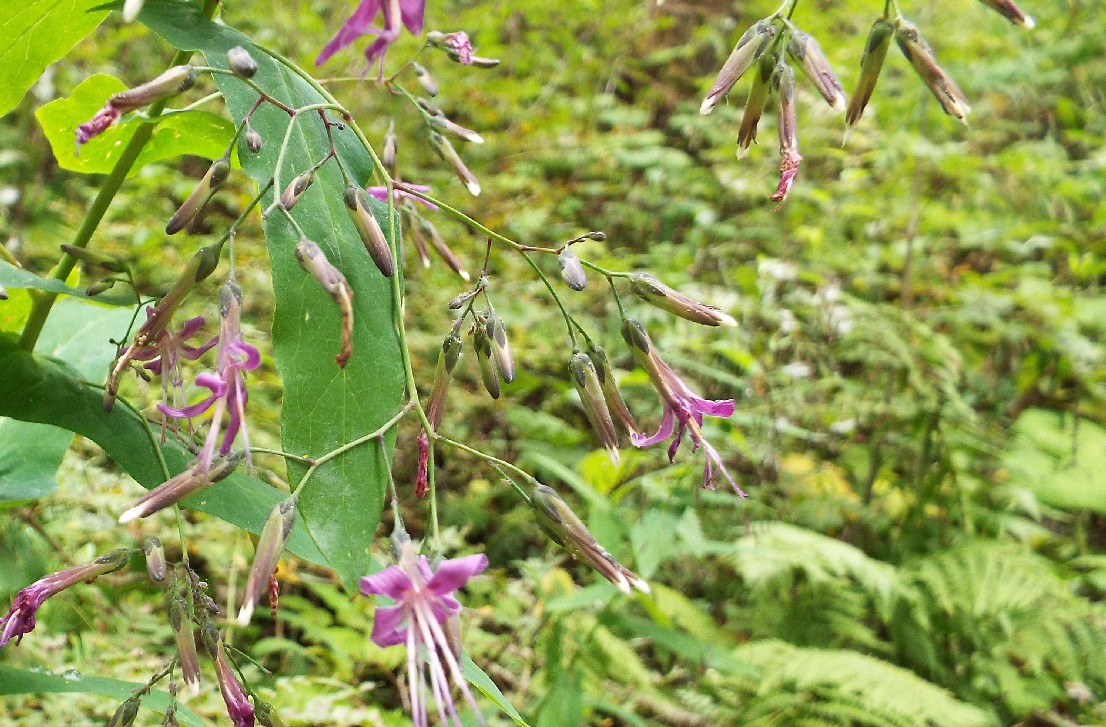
[0, 334, 327, 565]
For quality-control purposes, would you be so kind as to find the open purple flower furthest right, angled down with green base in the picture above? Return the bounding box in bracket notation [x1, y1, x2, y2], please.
[622, 320, 745, 497]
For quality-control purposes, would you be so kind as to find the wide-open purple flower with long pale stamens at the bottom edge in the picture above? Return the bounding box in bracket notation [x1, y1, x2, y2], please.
[361, 541, 488, 727]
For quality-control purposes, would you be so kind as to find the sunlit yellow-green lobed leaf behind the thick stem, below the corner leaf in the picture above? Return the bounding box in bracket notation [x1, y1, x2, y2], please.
[34, 73, 234, 176]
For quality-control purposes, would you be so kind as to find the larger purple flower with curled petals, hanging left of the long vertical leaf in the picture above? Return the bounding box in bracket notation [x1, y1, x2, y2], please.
[157, 282, 261, 471]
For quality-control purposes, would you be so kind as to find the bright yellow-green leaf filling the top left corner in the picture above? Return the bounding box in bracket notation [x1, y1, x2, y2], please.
[0, 0, 107, 115]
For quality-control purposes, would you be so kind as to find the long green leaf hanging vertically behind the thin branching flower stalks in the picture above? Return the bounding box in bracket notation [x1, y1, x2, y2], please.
[139, 0, 404, 590]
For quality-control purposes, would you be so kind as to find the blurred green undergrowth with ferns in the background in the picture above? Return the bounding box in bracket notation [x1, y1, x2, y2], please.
[0, 0, 1106, 727]
